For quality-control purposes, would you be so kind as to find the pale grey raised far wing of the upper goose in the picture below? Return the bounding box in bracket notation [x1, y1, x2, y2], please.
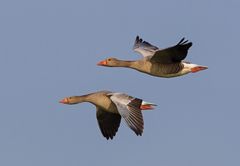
[133, 36, 159, 57]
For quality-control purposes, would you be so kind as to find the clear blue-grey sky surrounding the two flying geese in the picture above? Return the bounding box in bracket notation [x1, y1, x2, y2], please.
[0, 0, 240, 166]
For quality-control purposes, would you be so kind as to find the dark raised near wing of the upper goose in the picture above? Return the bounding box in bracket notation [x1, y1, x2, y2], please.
[150, 38, 192, 64]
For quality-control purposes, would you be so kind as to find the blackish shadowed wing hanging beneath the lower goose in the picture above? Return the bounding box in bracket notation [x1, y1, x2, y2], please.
[97, 107, 121, 139]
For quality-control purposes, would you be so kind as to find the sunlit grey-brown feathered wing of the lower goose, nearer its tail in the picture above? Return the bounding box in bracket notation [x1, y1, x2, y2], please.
[110, 93, 144, 135]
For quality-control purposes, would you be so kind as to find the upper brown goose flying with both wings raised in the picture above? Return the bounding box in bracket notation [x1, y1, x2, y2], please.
[97, 36, 208, 78]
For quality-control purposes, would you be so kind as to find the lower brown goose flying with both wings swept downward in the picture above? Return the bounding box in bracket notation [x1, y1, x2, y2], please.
[59, 91, 156, 140]
